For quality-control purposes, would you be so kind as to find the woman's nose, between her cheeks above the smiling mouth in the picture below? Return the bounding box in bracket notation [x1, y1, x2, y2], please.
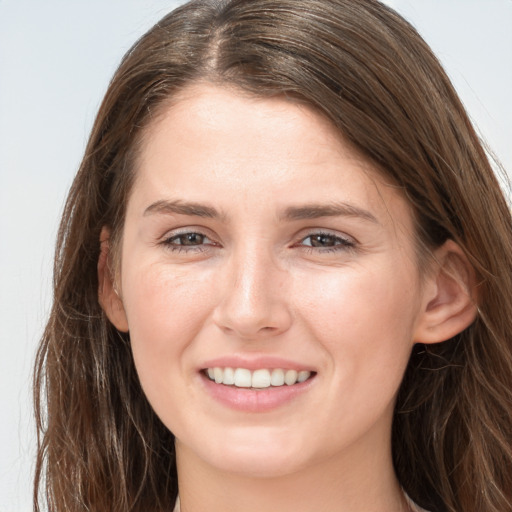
[214, 250, 292, 340]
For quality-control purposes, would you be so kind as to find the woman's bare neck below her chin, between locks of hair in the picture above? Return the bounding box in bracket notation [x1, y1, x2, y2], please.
[176, 434, 410, 512]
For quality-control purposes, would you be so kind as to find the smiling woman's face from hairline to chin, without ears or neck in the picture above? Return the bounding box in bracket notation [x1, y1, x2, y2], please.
[112, 85, 432, 475]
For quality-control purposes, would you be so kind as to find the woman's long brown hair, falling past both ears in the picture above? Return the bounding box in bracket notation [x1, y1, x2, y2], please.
[34, 0, 512, 512]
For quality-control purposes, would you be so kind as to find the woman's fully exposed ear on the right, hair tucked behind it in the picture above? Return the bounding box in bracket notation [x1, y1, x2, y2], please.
[414, 240, 477, 343]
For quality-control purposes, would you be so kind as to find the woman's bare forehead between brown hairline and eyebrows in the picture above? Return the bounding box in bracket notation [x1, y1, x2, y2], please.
[132, 84, 411, 234]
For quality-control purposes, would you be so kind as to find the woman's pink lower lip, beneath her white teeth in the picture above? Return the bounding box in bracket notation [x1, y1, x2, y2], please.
[200, 373, 315, 412]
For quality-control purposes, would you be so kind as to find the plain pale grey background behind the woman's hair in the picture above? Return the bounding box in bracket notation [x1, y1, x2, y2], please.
[0, 0, 512, 512]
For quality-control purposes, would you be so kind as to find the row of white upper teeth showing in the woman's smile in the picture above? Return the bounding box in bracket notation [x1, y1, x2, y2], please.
[206, 367, 311, 389]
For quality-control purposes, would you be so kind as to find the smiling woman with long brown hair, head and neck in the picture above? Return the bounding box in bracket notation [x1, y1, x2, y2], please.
[35, 0, 512, 512]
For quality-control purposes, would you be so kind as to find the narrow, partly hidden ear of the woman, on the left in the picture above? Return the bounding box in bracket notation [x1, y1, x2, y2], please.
[98, 227, 128, 332]
